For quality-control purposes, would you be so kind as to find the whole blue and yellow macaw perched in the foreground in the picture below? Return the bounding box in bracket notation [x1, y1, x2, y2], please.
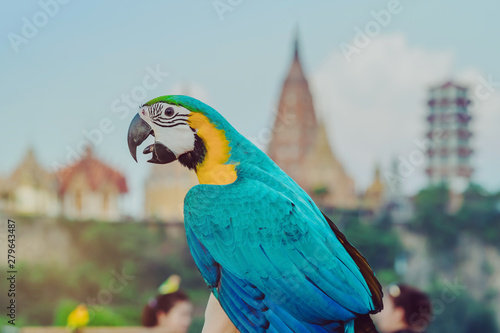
[128, 95, 382, 333]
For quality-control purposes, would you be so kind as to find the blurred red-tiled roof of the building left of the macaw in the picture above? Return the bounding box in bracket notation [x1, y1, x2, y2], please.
[58, 148, 128, 194]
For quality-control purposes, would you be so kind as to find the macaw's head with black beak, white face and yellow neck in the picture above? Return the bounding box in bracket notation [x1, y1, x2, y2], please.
[127, 95, 236, 184]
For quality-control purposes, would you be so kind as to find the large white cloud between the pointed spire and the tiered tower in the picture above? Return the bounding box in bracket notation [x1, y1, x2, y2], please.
[311, 34, 500, 193]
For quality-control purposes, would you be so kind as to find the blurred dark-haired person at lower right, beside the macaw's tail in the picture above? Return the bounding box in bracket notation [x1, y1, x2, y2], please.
[373, 284, 432, 333]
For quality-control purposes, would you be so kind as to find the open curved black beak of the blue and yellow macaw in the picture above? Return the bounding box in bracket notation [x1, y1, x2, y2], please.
[127, 114, 177, 164]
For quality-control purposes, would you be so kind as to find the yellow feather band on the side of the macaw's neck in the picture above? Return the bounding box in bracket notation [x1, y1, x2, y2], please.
[188, 112, 237, 185]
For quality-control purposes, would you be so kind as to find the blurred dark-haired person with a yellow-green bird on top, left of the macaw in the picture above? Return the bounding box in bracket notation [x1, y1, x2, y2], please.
[142, 275, 193, 333]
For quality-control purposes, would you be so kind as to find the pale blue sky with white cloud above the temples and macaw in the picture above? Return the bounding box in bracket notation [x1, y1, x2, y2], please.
[0, 0, 500, 214]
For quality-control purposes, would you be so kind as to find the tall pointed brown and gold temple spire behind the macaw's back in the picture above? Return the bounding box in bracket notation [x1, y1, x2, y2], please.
[267, 26, 357, 209]
